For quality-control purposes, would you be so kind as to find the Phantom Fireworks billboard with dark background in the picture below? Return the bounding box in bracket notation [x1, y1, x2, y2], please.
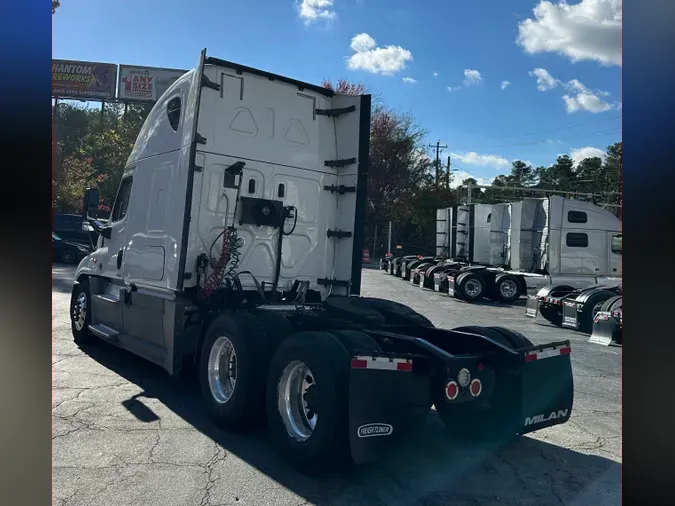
[52, 60, 117, 100]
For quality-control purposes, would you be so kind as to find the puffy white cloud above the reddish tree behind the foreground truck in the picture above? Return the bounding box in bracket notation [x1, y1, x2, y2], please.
[347, 33, 413, 75]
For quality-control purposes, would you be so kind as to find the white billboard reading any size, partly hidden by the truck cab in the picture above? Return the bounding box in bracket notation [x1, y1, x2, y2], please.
[117, 65, 187, 102]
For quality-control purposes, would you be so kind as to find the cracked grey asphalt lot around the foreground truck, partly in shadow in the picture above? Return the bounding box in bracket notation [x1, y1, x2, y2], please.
[52, 264, 621, 506]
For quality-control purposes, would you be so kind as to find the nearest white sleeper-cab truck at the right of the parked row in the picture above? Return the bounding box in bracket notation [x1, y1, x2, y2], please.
[445, 196, 621, 303]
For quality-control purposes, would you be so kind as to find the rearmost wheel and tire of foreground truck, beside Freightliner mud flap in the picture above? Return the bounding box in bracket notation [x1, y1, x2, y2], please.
[267, 331, 350, 474]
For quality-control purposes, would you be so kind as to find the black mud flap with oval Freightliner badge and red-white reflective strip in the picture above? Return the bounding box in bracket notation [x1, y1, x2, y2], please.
[349, 357, 431, 464]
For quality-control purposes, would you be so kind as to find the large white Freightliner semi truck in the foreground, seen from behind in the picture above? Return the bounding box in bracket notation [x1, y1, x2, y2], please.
[70, 50, 573, 472]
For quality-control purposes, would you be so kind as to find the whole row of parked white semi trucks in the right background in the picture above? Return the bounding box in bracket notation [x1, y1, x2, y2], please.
[380, 196, 623, 344]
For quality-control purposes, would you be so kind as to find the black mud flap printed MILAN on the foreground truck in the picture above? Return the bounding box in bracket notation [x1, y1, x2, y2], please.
[520, 341, 574, 434]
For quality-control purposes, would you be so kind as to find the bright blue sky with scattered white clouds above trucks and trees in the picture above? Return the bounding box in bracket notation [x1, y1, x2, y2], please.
[53, 0, 621, 186]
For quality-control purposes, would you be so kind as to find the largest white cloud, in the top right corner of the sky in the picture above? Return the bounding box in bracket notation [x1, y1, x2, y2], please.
[516, 0, 622, 65]
